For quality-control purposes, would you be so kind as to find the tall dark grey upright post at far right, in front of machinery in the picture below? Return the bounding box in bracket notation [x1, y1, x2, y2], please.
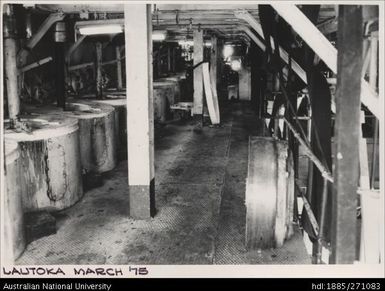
[330, 5, 363, 264]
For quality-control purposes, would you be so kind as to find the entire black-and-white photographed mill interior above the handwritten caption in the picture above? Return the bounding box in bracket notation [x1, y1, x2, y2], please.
[1, 3, 384, 265]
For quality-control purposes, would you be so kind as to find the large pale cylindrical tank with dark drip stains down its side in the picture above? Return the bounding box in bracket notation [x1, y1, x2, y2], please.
[5, 114, 83, 211]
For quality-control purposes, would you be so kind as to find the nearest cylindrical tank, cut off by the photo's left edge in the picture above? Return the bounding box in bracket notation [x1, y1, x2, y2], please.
[2, 141, 26, 264]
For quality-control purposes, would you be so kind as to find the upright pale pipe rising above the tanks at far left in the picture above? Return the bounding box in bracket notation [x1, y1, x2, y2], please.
[4, 4, 20, 128]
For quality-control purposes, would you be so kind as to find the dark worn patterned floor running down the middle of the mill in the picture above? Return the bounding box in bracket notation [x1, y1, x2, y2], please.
[17, 104, 310, 265]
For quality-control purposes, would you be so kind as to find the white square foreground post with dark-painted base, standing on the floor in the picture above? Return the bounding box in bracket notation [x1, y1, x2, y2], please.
[124, 4, 155, 219]
